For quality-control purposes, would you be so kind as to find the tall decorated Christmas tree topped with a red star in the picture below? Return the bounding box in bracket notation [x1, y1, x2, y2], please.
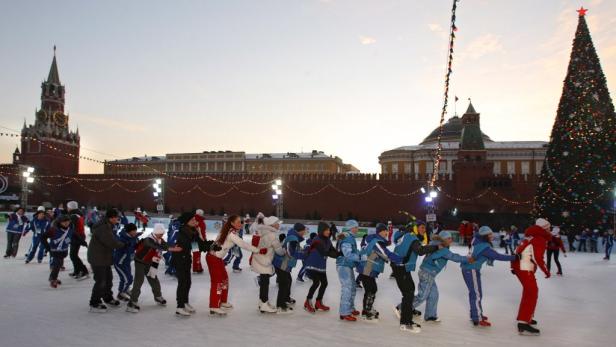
[534, 8, 616, 232]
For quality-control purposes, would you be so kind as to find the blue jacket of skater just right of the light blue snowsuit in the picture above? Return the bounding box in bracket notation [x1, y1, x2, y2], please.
[357, 234, 403, 277]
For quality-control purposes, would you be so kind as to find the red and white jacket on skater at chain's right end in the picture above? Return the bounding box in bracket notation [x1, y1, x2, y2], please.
[511, 225, 552, 275]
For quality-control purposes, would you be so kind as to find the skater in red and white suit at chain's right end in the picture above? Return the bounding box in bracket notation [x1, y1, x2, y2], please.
[511, 218, 552, 335]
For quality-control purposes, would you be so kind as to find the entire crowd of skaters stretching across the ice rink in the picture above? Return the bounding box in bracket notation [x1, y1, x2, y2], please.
[5, 201, 614, 335]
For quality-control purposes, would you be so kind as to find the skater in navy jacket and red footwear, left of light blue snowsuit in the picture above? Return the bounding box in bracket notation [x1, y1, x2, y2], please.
[304, 222, 340, 313]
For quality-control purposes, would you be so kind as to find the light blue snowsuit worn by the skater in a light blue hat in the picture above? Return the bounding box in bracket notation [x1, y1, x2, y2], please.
[336, 232, 361, 316]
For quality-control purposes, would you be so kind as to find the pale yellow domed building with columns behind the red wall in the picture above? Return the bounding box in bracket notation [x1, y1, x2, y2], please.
[379, 103, 548, 179]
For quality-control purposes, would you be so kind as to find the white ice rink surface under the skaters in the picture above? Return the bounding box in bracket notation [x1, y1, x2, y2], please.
[0, 224, 616, 347]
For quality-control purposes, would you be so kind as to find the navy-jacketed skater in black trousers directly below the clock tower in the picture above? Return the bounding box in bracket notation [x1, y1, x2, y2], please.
[41, 214, 73, 288]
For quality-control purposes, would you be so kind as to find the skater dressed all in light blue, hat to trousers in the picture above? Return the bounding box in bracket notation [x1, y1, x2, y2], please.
[336, 219, 361, 322]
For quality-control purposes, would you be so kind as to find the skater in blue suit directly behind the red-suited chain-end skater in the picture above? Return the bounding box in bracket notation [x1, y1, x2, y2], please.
[460, 225, 517, 327]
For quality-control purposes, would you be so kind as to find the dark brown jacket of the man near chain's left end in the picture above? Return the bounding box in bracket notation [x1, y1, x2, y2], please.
[88, 220, 124, 266]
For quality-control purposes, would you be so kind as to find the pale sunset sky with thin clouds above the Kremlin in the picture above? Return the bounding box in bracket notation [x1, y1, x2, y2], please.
[0, 0, 616, 173]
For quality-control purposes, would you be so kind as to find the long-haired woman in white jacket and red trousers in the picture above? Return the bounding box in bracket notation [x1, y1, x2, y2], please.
[205, 215, 267, 315]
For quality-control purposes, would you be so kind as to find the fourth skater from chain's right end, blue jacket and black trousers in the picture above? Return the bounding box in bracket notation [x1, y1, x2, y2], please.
[391, 221, 439, 334]
